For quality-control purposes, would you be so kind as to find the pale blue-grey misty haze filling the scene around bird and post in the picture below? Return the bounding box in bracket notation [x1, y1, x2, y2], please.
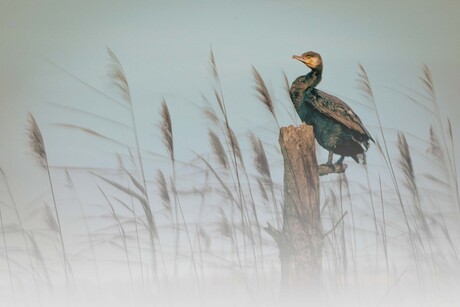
[0, 0, 460, 306]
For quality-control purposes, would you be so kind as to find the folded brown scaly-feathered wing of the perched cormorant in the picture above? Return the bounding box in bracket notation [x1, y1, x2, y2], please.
[305, 89, 374, 141]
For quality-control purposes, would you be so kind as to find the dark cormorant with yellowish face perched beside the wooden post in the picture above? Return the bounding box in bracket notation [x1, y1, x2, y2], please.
[289, 51, 374, 165]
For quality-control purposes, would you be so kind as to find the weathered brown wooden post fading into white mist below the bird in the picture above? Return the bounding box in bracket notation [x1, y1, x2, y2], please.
[267, 124, 323, 294]
